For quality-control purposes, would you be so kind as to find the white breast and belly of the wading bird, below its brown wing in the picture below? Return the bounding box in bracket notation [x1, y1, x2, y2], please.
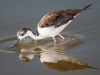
[38, 20, 72, 37]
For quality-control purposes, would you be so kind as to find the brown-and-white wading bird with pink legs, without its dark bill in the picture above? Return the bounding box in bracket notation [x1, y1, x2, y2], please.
[17, 4, 92, 43]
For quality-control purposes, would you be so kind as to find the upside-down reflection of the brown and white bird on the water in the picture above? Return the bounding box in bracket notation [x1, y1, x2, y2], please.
[16, 44, 96, 72]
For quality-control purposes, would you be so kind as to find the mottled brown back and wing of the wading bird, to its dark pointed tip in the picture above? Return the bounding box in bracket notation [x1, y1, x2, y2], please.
[38, 5, 91, 28]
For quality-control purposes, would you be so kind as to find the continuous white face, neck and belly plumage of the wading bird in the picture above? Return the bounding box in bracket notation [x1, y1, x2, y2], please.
[17, 20, 72, 40]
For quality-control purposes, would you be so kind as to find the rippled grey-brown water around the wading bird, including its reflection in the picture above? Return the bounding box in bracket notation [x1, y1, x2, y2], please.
[0, 0, 100, 75]
